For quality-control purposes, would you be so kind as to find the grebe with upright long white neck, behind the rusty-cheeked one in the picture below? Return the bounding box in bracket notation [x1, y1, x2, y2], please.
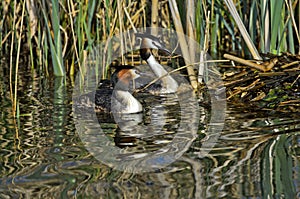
[135, 33, 178, 93]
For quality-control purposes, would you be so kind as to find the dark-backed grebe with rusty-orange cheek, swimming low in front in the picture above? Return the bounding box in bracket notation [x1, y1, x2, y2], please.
[79, 65, 143, 114]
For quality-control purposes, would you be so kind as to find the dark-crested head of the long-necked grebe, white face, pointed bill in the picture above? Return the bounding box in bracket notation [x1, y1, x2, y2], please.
[135, 33, 171, 60]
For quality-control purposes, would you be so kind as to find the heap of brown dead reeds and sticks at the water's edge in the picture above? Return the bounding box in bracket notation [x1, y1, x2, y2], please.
[221, 53, 300, 112]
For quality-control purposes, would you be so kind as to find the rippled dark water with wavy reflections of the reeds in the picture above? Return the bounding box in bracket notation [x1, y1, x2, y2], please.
[0, 65, 300, 198]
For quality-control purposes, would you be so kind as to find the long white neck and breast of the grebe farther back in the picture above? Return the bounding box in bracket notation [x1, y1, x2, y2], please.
[146, 54, 178, 93]
